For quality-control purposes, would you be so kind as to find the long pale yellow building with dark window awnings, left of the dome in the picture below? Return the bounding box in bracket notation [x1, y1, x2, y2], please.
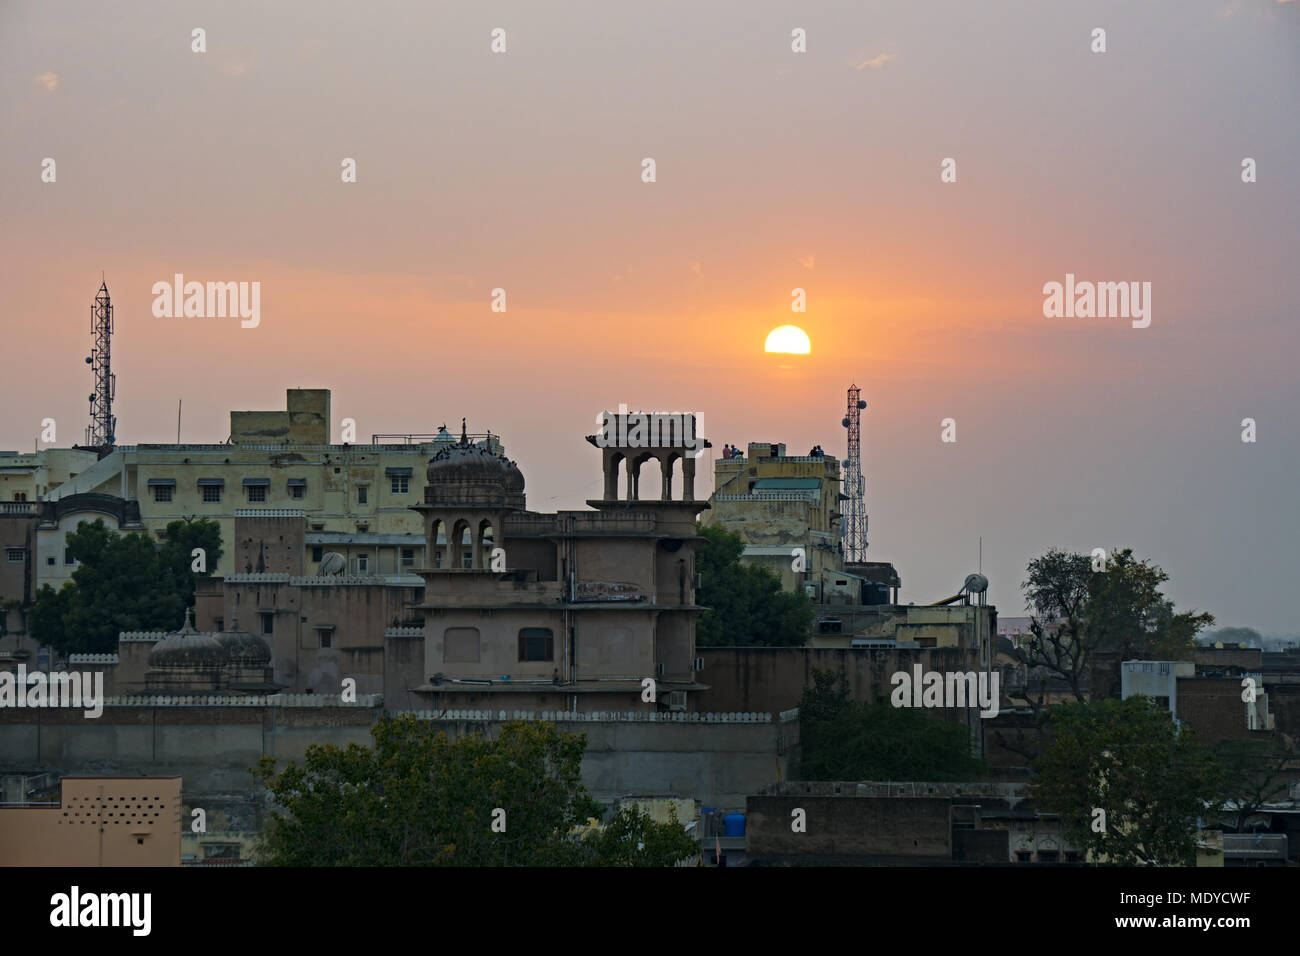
[36, 389, 502, 587]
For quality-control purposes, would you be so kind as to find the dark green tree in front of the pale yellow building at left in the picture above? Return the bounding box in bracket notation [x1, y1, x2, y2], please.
[31, 519, 221, 653]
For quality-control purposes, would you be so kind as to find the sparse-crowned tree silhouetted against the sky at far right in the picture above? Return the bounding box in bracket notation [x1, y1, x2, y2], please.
[1021, 548, 1214, 704]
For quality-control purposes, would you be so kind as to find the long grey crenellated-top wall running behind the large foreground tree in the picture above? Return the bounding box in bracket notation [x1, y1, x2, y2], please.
[0, 702, 798, 856]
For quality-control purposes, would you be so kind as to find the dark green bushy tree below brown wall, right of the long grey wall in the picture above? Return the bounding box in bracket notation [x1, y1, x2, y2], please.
[800, 670, 988, 780]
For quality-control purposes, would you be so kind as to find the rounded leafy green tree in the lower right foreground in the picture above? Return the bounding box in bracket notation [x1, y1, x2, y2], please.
[1032, 697, 1219, 866]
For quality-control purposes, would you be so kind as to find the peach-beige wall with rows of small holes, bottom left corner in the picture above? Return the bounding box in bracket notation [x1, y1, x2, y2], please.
[0, 777, 181, 866]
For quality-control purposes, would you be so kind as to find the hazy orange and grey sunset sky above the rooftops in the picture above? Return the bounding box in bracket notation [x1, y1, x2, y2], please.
[0, 0, 1300, 632]
